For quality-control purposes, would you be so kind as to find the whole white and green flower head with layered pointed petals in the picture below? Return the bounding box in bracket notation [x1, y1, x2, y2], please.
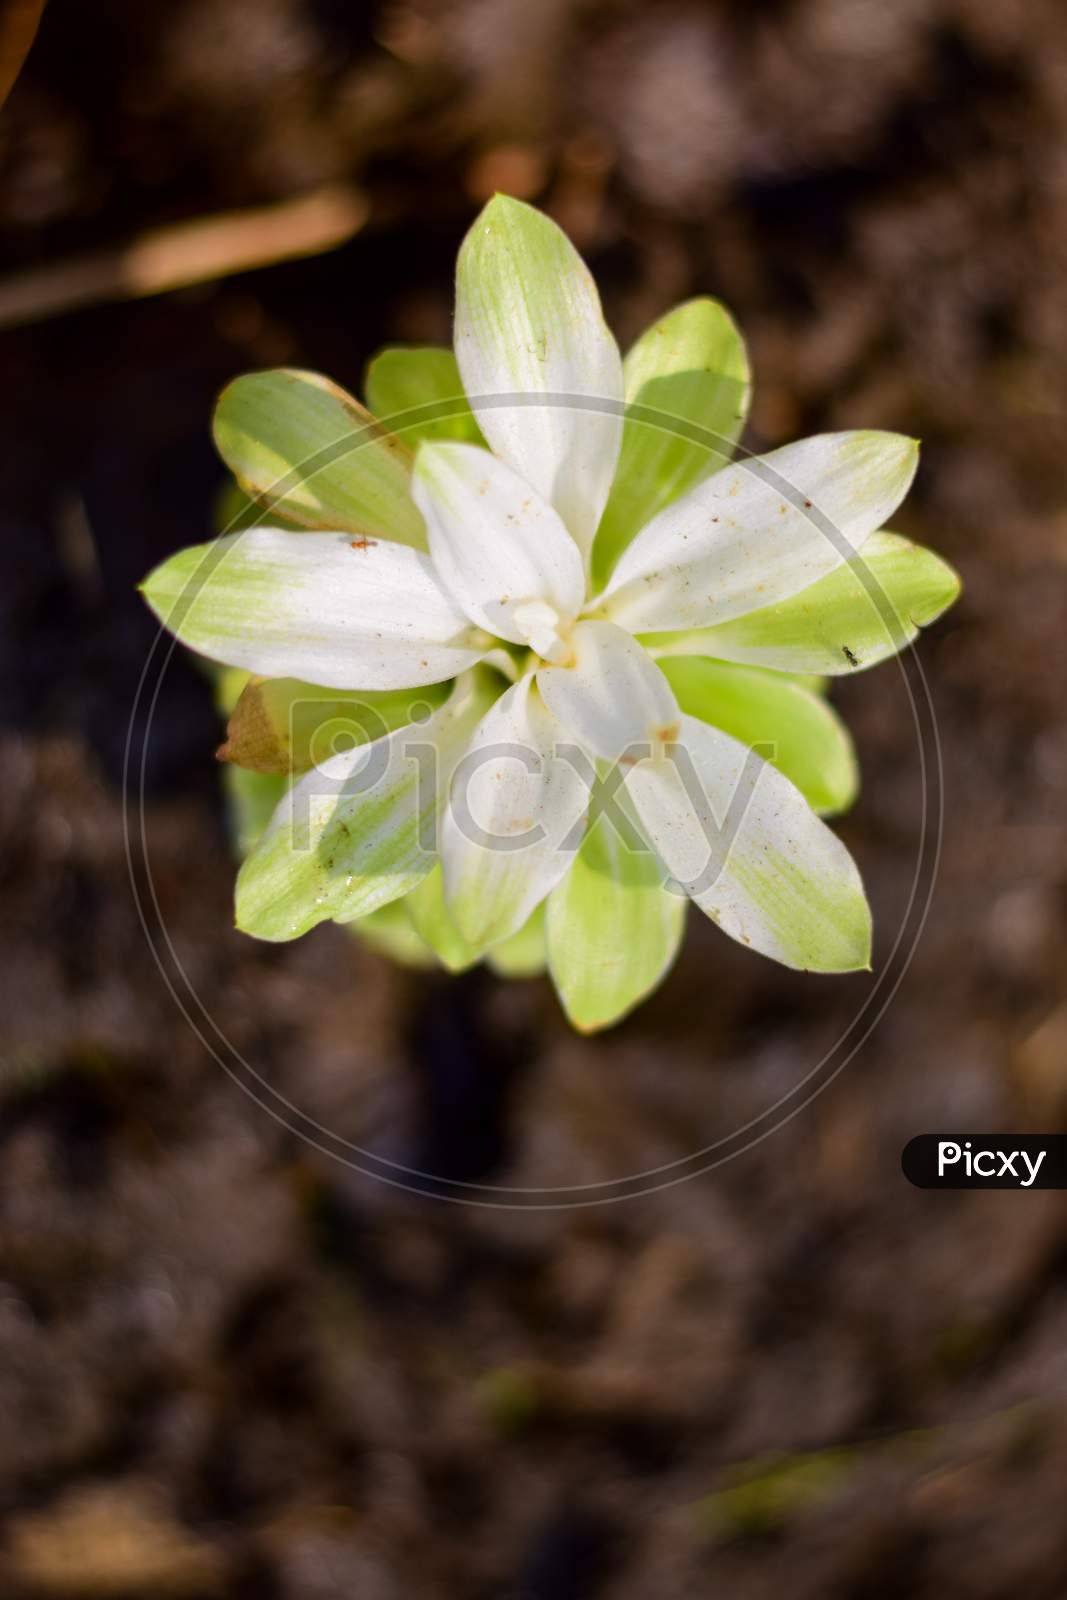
[144, 197, 958, 1030]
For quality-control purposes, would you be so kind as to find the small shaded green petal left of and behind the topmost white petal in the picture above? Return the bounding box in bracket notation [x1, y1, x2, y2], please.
[363, 344, 485, 448]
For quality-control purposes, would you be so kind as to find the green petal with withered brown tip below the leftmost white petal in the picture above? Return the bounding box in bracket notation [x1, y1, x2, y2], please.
[218, 678, 448, 778]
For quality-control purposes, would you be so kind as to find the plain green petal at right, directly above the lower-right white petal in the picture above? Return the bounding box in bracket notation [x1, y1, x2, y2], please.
[659, 656, 859, 816]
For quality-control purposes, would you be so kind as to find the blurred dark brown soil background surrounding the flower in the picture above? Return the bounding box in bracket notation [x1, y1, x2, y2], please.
[0, 0, 1067, 1600]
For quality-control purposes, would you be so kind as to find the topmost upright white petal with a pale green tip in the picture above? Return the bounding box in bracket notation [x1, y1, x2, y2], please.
[456, 195, 622, 555]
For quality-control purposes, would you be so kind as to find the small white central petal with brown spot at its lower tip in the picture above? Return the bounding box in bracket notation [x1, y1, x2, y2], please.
[537, 621, 678, 762]
